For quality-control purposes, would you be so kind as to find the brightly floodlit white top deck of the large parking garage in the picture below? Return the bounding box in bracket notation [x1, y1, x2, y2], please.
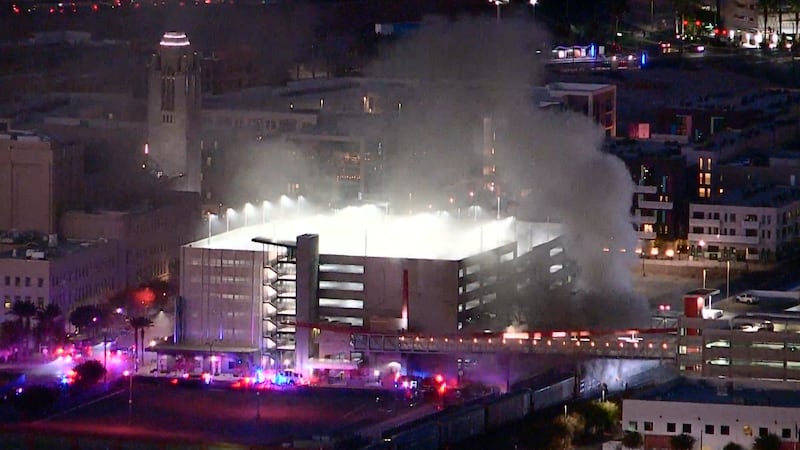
[187, 206, 561, 260]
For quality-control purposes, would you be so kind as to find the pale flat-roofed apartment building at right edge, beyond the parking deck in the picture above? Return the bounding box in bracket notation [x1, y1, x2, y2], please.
[688, 186, 800, 261]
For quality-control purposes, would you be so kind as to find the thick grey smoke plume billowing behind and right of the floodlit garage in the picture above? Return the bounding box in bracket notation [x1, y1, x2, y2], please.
[368, 15, 647, 327]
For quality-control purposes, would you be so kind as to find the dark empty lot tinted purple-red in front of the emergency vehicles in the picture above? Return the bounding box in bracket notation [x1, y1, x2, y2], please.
[0, 379, 419, 445]
